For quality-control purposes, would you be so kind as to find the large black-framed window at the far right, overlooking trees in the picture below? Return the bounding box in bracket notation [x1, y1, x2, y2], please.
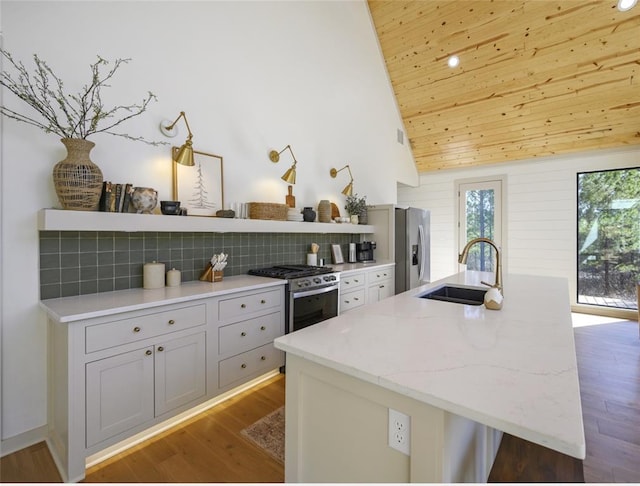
[577, 168, 640, 309]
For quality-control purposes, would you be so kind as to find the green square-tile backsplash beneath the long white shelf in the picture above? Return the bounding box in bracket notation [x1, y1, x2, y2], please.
[39, 231, 359, 299]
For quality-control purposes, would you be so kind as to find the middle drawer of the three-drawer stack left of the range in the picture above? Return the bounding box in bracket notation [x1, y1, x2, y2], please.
[218, 311, 284, 356]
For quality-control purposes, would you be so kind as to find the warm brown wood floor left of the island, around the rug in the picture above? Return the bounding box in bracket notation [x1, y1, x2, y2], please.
[0, 375, 285, 483]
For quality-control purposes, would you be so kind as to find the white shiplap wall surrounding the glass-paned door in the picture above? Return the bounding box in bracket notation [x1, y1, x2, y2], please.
[398, 147, 640, 304]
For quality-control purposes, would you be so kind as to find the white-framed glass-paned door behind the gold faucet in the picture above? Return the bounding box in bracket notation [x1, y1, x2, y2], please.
[458, 180, 502, 272]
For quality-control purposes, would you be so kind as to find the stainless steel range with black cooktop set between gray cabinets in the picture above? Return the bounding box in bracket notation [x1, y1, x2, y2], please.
[248, 265, 340, 333]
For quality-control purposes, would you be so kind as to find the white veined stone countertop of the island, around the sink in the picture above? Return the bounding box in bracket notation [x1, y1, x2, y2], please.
[275, 272, 586, 459]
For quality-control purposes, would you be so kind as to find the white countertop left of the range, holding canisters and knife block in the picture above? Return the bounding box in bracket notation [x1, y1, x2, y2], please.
[40, 275, 286, 322]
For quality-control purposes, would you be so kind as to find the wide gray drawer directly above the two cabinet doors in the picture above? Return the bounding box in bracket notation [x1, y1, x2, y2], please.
[86, 304, 207, 353]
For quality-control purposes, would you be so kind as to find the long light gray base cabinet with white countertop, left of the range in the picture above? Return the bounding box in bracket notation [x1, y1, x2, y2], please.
[42, 276, 284, 481]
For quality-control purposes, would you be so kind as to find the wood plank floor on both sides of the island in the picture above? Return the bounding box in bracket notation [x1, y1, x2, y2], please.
[0, 321, 640, 483]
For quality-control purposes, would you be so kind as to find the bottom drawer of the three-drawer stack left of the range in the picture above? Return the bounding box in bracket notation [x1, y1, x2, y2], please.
[218, 344, 284, 388]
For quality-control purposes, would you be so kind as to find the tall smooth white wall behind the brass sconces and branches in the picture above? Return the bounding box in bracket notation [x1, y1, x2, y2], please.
[0, 0, 415, 439]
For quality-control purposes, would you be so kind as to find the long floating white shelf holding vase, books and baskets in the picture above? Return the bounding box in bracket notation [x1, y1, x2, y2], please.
[38, 209, 373, 234]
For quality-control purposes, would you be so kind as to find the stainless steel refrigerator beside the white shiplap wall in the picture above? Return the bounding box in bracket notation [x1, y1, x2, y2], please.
[395, 208, 431, 294]
